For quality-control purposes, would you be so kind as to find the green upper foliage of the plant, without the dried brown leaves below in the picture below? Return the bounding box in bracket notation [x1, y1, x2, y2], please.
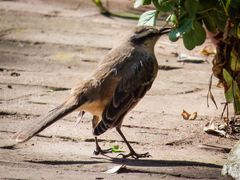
[134, 0, 230, 50]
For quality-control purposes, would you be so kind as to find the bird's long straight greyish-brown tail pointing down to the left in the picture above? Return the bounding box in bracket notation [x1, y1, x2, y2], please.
[12, 96, 84, 143]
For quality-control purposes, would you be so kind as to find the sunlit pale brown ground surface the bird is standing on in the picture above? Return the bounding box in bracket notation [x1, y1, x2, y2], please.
[0, 0, 237, 179]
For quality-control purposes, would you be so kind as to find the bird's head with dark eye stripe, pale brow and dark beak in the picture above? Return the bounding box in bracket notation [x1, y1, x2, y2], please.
[129, 26, 171, 48]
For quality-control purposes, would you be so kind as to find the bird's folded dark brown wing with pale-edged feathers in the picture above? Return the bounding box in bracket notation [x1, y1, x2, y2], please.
[94, 49, 157, 135]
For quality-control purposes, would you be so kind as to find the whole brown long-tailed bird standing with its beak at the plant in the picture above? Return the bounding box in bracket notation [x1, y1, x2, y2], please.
[12, 26, 171, 159]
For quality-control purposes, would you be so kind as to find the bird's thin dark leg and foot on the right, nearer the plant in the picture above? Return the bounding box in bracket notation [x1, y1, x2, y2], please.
[116, 127, 151, 159]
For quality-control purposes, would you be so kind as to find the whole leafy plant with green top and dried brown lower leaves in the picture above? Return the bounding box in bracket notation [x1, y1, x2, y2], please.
[134, 0, 240, 114]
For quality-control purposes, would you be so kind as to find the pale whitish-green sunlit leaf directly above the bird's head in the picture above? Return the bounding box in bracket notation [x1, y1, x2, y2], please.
[138, 10, 158, 26]
